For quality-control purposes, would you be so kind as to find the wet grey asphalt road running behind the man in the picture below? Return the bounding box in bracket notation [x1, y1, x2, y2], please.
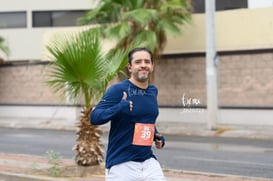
[0, 128, 273, 178]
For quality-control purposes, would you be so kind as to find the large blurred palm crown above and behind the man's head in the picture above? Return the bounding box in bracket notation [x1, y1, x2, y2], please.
[79, 0, 191, 65]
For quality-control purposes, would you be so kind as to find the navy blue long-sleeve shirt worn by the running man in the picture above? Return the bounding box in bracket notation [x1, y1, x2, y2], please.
[90, 80, 159, 168]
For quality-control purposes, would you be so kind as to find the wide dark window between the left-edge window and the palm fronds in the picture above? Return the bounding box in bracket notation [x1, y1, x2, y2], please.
[32, 11, 85, 27]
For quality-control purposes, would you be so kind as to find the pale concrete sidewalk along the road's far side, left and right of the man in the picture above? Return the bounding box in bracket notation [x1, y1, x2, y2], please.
[0, 108, 273, 139]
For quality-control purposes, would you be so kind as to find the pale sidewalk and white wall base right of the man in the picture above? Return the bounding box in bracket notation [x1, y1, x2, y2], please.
[157, 108, 273, 139]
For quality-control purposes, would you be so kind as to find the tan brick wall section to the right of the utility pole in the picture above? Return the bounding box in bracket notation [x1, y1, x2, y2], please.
[218, 50, 273, 107]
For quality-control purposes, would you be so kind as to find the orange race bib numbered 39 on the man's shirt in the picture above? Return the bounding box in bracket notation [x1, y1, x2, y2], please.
[133, 123, 155, 146]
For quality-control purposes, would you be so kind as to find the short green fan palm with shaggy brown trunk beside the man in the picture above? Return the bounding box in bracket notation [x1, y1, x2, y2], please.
[46, 28, 127, 166]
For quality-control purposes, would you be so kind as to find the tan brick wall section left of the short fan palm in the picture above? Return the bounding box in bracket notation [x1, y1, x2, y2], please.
[0, 64, 65, 105]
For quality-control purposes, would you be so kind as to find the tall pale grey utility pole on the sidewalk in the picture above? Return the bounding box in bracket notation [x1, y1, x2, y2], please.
[205, 0, 219, 130]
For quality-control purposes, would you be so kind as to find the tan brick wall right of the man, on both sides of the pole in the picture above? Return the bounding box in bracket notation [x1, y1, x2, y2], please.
[155, 51, 273, 107]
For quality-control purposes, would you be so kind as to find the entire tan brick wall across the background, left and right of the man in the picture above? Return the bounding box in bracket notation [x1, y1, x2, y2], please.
[0, 51, 273, 107]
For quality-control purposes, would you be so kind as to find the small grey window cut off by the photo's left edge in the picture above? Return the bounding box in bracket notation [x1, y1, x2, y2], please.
[0, 11, 27, 28]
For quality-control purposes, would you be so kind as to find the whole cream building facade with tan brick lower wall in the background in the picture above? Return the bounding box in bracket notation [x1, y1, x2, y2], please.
[0, 0, 273, 121]
